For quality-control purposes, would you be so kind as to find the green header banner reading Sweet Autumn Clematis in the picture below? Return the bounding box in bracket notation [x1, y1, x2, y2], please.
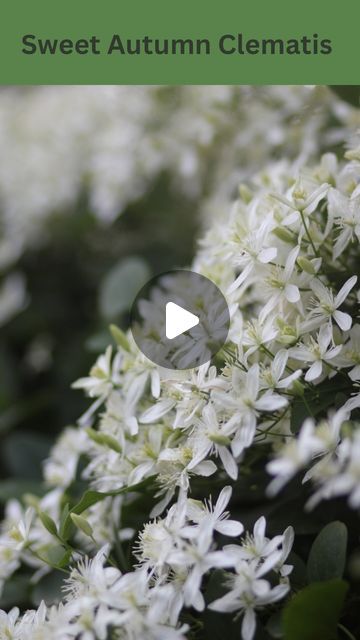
[0, 0, 360, 85]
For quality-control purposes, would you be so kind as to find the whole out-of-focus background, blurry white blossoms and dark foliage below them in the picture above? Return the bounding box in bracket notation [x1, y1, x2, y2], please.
[0, 87, 360, 502]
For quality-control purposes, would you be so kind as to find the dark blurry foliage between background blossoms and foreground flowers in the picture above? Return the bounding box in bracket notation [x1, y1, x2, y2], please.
[0, 178, 198, 490]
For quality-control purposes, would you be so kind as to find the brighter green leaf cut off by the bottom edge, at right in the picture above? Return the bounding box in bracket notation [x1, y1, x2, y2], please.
[283, 579, 348, 640]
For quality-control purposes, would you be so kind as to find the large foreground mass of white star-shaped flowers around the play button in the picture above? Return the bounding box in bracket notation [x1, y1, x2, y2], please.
[0, 92, 360, 640]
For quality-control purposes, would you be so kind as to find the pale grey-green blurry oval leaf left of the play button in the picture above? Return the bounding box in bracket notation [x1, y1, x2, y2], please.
[99, 256, 150, 320]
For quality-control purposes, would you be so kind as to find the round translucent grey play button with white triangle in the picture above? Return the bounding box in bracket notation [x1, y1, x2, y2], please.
[130, 269, 230, 369]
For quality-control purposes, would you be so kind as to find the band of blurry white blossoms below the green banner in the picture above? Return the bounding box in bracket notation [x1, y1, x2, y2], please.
[0, 86, 359, 324]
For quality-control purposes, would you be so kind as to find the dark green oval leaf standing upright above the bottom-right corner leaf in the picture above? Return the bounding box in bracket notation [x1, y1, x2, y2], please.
[307, 521, 348, 582]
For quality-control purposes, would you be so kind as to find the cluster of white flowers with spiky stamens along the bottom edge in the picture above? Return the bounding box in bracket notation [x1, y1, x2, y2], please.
[0, 487, 293, 640]
